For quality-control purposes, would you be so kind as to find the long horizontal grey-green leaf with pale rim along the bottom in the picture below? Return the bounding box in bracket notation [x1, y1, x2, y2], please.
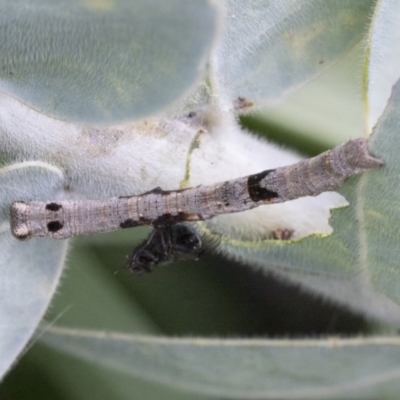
[40, 327, 400, 399]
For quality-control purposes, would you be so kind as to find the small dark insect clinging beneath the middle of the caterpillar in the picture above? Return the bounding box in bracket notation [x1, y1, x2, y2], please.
[128, 222, 220, 274]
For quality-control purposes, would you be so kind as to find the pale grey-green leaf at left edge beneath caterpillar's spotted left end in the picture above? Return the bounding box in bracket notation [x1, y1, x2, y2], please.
[0, 162, 67, 376]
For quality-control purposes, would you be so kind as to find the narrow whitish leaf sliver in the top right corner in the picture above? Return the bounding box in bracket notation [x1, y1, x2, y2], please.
[363, 0, 400, 132]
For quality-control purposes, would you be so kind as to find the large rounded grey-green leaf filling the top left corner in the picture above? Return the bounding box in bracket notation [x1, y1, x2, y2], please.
[0, 0, 220, 123]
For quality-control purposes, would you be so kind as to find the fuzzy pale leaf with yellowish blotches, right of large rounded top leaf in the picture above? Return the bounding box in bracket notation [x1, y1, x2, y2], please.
[211, 0, 374, 103]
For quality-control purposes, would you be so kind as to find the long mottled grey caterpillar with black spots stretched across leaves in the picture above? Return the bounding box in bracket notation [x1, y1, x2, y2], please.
[11, 139, 383, 239]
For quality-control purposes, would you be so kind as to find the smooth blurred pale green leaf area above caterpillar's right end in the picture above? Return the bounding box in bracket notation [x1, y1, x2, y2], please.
[258, 43, 366, 149]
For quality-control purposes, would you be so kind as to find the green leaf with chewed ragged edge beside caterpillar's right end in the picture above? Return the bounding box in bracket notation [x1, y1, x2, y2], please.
[216, 78, 400, 325]
